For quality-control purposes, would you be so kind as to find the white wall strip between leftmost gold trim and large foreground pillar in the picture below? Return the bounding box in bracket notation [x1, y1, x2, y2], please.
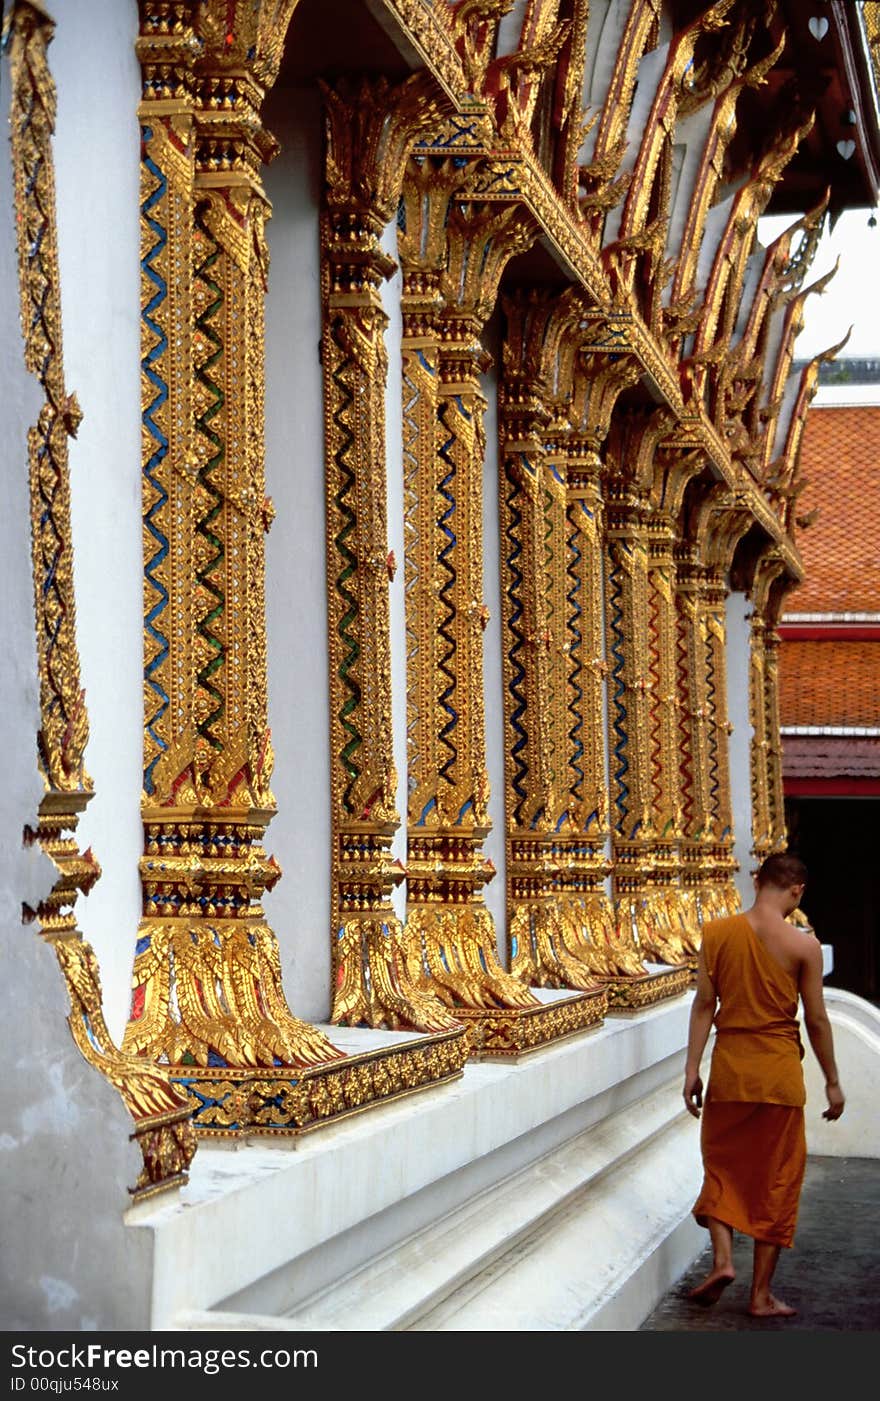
[49, 0, 143, 1040]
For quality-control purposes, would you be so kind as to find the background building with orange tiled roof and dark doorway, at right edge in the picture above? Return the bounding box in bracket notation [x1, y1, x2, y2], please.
[778, 367, 880, 1005]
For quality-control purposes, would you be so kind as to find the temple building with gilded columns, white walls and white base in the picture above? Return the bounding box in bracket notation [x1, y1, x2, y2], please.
[0, 0, 880, 1331]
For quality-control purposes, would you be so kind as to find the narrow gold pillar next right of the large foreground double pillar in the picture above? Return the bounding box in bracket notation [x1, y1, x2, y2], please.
[321, 77, 459, 1031]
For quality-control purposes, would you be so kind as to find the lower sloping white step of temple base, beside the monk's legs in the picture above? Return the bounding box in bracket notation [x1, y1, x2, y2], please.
[175, 1077, 703, 1332]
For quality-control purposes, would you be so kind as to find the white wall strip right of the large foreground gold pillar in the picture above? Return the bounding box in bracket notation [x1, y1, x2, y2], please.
[263, 88, 331, 1021]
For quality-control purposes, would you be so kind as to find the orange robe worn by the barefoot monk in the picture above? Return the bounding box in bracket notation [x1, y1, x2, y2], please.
[694, 915, 807, 1245]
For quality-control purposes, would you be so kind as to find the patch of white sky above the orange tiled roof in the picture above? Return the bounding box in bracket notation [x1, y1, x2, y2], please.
[759, 209, 880, 360]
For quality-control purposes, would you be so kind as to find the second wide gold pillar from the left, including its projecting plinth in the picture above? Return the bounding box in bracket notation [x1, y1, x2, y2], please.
[398, 177, 604, 1056]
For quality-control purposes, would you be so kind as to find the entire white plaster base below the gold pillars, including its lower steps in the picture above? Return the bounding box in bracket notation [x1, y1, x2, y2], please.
[128, 993, 702, 1331]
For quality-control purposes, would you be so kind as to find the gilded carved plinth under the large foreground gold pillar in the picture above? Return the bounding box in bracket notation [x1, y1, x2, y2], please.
[168, 1026, 468, 1139]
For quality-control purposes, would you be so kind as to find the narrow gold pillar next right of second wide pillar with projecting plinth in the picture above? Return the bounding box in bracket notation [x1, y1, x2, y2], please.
[499, 293, 605, 992]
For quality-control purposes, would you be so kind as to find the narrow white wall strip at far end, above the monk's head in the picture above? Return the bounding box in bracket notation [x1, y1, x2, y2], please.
[726, 593, 754, 905]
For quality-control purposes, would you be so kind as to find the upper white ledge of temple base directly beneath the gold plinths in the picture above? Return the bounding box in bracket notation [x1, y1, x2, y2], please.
[126, 992, 692, 1330]
